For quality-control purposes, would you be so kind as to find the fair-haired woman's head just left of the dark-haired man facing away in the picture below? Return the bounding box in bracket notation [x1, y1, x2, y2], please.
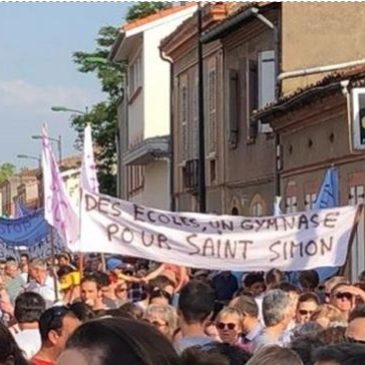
[144, 304, 178, 340]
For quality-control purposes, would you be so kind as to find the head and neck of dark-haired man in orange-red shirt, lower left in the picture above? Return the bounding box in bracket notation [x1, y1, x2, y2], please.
[31, 306, 81, 365]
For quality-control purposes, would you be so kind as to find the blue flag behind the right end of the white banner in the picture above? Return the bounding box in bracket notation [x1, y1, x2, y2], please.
[313, 167, 340, 282]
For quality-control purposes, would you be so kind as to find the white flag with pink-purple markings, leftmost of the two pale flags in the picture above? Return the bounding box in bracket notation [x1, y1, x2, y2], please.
[42, 125, 80, 245]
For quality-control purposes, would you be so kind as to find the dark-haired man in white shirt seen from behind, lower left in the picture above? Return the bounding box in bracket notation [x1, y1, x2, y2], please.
[13, 292, 46, 359]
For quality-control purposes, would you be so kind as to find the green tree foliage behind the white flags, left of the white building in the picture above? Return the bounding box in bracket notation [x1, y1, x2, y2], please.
[71, 26, 125, 195]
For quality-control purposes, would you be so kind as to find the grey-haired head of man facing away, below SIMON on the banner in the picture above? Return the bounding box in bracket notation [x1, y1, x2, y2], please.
[262, 289, 292, 330]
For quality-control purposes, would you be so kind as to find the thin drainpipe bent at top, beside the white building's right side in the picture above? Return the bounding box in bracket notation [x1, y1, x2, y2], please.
[159, 48, 176, 212]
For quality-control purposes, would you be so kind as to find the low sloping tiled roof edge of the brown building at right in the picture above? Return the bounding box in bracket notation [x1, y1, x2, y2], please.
[252, 64, 365, 120]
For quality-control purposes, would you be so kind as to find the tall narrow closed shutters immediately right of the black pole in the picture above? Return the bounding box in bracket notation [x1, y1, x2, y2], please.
[207, 58, 217, 153]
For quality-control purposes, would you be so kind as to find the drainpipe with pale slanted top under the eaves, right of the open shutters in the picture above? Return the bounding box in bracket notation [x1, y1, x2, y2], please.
[253, 8, 281, 208]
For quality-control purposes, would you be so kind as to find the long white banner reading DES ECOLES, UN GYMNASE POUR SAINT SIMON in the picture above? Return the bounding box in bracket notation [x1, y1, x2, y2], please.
[69, 191, 359, 271]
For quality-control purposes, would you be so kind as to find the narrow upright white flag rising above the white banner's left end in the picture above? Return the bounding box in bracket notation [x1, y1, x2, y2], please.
[81, 124, 99, 194]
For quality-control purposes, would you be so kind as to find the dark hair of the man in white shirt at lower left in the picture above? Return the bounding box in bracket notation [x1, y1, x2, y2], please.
[14, 292, 46, 323]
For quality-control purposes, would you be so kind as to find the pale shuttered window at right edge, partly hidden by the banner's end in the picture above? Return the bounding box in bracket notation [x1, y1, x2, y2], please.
[349, 185, 365, 280]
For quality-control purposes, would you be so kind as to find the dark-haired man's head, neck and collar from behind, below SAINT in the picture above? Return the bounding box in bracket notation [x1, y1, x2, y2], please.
[175, 281, 214, 353]
